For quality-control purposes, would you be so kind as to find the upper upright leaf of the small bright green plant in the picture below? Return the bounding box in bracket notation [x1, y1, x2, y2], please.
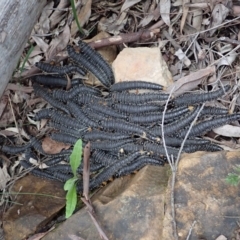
[70, 139, 82, 176]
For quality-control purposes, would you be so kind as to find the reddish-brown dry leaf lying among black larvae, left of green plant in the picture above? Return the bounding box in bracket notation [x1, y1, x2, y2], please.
[42, 137, 70, 154]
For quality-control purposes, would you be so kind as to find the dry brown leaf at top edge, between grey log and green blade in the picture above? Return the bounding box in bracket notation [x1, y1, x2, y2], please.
[49, 0, 70, 29]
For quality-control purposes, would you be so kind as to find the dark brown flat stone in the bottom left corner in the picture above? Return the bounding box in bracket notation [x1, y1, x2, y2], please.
[3, 175, 66, 240]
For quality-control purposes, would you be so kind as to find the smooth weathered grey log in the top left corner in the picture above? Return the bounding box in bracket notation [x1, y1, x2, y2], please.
[0, 0, 47, 97]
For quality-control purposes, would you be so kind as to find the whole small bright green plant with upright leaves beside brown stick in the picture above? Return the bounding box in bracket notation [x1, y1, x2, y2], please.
[64, 139, 82, 218]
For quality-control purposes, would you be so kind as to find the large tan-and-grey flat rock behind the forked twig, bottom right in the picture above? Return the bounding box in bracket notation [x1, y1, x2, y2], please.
[162, 151, 240, 240]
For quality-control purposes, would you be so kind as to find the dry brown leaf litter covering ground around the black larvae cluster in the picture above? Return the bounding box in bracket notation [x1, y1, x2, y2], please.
[0, 0, 240, 238]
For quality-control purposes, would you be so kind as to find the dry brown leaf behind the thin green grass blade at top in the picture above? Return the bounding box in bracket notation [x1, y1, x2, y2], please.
[71, 0, 92, 36]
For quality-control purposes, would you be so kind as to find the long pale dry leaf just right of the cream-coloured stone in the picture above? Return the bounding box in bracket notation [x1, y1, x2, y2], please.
[167, 66, 216, 96]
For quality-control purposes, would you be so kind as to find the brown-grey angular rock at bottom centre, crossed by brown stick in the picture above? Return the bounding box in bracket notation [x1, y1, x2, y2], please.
[43, 166, 169, 240]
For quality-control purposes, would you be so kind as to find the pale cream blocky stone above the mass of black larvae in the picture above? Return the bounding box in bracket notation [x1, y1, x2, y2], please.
[112, 47, 173, 87]
